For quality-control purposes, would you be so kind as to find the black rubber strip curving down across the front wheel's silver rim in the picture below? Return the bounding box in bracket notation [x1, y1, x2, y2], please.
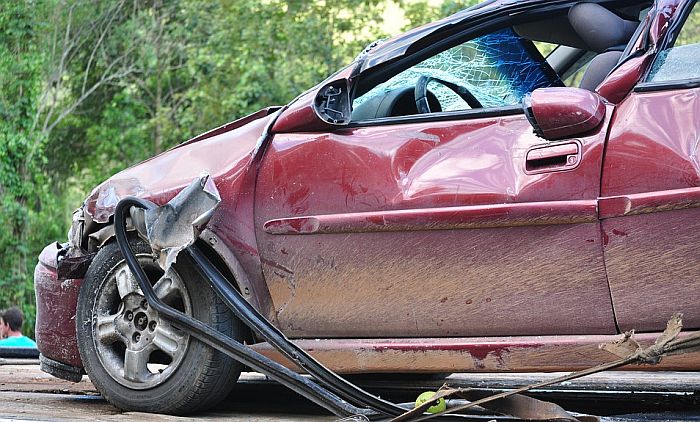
[114, 198, 376, 416]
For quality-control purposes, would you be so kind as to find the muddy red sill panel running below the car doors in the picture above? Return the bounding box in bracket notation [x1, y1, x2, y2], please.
[251, 334, 700, 373]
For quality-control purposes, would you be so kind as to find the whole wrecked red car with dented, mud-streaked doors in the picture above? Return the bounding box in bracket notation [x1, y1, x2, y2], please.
[35, 0, 700, 413]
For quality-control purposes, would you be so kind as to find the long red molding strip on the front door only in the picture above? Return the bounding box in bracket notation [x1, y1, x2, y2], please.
[263, 200, 598, 235]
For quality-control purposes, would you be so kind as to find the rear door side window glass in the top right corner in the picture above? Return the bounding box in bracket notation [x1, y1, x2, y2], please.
[647, 2, 700, 82]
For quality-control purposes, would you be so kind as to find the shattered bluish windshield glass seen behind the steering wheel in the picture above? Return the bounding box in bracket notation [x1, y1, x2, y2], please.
[353, 28, 563, 111]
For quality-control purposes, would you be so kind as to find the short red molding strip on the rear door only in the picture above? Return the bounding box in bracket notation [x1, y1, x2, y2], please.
[598, 188, 700, 219]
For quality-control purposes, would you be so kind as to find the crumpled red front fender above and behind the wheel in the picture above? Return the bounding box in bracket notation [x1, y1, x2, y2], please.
[74, 108, 280, 330]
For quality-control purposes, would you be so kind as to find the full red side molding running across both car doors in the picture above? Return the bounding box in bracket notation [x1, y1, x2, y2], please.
[263, 187, 700, 235]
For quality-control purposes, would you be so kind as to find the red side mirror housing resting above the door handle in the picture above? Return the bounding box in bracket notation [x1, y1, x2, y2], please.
[523, 87, 605, 140]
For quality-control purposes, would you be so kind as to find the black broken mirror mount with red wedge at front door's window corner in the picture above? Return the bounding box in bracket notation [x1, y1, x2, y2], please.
[272, 78, 352, 133]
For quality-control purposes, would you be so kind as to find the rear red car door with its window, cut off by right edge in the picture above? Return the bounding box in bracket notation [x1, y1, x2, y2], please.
[600, 1, 700, 331]
